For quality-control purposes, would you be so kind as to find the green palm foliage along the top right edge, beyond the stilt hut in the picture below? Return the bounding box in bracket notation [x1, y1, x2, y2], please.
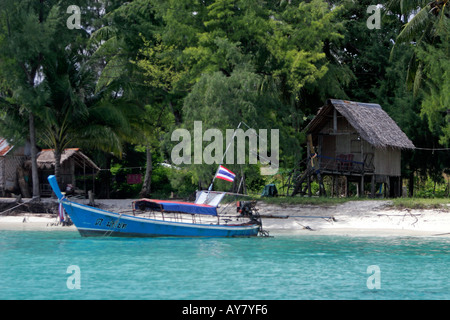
[389, 0, 450, 145]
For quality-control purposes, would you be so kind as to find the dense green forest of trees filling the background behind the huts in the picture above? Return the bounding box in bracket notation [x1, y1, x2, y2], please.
[0, 0, 450, 198]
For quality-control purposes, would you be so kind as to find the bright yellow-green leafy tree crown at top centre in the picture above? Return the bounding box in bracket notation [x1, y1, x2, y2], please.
[155, 0, 349, 166]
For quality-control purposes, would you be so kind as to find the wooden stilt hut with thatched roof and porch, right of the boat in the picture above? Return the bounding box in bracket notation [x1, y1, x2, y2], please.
[292, 99, 415, 197]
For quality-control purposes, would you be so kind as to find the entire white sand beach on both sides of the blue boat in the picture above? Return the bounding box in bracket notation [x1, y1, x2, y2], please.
[0, 200, 450, 236]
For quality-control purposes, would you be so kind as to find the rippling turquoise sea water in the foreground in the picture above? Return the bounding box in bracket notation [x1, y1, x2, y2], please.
[0, 231, 450, 300]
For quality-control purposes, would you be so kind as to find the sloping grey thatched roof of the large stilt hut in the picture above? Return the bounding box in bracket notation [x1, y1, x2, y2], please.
[304, 99, 415, 149]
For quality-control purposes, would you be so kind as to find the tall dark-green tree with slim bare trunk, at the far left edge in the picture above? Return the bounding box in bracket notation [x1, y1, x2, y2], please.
[0, 0, 60, 199]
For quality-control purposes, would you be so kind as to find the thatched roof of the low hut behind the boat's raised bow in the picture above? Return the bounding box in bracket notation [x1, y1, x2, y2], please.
[37, 148, 100, 171]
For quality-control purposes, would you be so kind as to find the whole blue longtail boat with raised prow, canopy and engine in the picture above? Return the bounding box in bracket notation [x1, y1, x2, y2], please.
[48, 175, 267, 237]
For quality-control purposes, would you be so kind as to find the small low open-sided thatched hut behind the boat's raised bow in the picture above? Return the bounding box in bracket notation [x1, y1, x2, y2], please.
[37, 148, 100, 196]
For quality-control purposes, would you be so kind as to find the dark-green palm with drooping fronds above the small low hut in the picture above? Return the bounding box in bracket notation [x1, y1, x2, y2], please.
[37, 51, 130, 185]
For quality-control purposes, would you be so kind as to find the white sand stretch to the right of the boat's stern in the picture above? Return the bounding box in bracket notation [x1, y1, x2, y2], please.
[260, 200, 450, 236]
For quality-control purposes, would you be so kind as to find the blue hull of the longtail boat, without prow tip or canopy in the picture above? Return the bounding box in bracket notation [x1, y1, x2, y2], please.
[61, 200, 260, 237]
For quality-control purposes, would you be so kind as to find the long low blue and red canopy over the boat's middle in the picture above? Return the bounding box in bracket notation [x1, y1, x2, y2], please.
[133, 199, 217, 216]
